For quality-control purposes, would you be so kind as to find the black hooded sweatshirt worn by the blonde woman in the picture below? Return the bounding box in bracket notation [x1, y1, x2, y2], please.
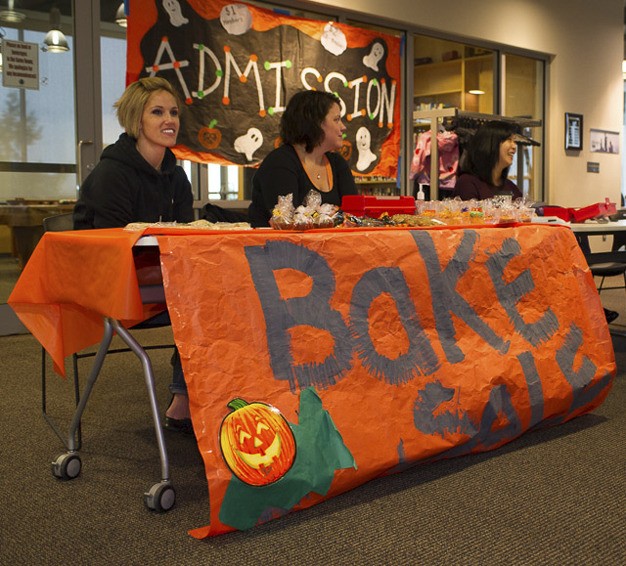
[74, 134, 194, 230]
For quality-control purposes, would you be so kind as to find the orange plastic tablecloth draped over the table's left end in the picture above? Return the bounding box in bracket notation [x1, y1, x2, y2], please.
[8, 229, 150, 374]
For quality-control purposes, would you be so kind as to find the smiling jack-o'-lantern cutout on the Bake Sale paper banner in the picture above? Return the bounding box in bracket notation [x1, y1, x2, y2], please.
[220, 399, 296, 486]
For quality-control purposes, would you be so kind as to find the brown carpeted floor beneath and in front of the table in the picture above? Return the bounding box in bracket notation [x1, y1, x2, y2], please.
[0, 322, 626, 566]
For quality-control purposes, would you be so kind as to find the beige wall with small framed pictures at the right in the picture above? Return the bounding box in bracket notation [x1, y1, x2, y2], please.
[310, 0, 625, 206]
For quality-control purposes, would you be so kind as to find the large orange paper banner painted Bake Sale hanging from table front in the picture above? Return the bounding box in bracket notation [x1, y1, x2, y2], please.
[159, 225, 615, 537]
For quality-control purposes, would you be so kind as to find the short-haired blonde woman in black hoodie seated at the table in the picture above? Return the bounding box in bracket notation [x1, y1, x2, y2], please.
[74, 77, 194, 432]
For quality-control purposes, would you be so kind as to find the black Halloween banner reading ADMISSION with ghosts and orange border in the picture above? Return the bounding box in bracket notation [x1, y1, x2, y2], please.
[127, 0, 401, 177]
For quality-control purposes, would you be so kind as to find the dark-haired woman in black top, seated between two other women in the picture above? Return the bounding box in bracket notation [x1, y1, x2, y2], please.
[248, 90, 357, 227]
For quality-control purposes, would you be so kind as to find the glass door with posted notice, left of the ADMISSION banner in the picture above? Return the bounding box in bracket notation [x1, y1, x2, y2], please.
[0, 0, 126, 328]
